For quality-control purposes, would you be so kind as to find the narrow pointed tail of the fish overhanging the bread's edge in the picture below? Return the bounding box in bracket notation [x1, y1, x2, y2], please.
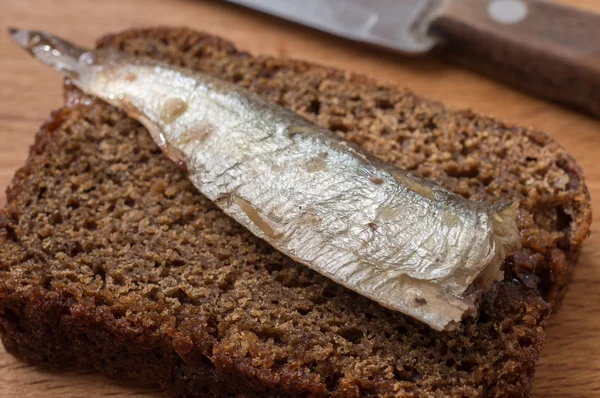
[8, 28, 89, 79]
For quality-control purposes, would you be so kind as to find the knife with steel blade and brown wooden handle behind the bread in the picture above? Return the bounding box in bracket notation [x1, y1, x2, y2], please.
[228, 0, 600, 117]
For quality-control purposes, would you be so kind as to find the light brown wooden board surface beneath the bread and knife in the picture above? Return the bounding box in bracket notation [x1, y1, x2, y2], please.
[0, 0, 600, 398]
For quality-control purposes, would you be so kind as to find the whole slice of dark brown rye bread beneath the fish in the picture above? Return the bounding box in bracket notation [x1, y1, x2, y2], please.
[0, 28, 591, 397]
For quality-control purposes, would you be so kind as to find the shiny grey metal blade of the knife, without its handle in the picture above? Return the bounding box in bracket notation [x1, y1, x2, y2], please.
[229, 0, 442, 54]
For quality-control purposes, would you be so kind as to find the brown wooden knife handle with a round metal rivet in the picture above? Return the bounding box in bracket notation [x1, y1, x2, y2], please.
[431, 0, 600, 117]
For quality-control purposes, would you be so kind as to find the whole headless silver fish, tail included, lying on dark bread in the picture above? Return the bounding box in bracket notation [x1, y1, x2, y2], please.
[11, 29, 520, 330]
